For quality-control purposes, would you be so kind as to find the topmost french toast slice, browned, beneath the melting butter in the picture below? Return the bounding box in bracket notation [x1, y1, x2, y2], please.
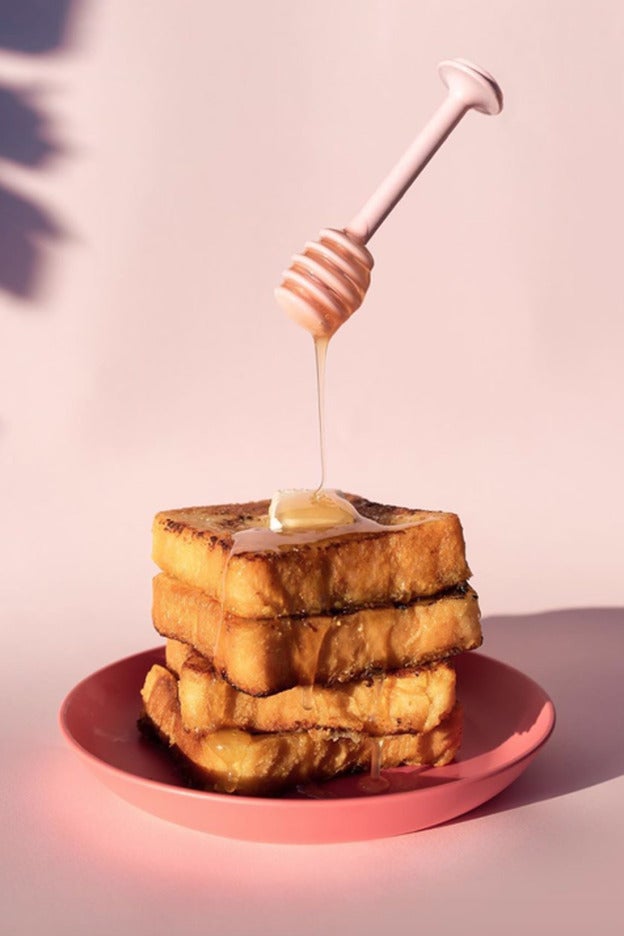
[152, 494, 471, 618]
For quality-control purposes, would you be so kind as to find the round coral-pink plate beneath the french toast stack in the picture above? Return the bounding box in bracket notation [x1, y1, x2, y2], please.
[60, 648, 555, 843]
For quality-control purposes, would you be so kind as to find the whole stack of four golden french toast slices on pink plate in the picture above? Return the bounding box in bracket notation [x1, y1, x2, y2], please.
[140, 495, 481, 795]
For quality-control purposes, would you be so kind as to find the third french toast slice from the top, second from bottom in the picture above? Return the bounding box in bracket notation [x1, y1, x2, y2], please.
[166, 640, 455, 736]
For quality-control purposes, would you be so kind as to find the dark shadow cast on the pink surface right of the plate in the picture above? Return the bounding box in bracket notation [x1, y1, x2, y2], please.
[456, 608, 624, 819]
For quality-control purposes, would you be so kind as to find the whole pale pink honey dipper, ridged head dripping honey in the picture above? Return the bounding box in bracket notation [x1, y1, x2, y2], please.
[275, 59, 503, 339]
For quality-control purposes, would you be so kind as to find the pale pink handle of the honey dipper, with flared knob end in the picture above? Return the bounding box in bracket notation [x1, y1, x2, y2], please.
[345, 59, 503, 244]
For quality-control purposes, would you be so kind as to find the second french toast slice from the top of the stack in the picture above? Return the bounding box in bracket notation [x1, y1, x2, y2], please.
[152, 573, 482, 695]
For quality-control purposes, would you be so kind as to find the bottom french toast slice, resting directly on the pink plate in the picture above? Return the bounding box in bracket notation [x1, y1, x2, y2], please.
[139, 664, 462, 796]
